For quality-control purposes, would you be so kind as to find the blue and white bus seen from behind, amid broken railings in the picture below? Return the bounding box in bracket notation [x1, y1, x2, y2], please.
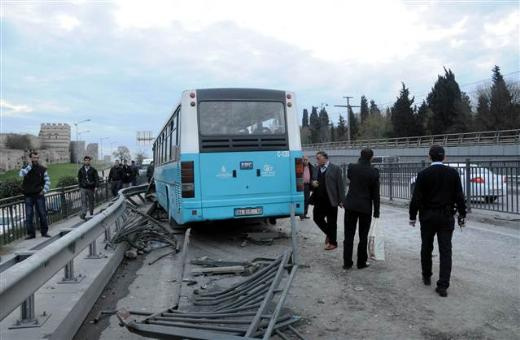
[153, 88, 303, 225]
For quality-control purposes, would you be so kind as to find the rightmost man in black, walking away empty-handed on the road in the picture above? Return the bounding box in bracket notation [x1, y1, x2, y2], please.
[410, 145, 466, 297]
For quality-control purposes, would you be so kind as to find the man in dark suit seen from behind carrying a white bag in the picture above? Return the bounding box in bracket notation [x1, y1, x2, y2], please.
[343, 149, 379, 269]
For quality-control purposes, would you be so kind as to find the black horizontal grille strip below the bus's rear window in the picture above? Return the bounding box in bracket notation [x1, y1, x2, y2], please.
[200, 136, 289, 152]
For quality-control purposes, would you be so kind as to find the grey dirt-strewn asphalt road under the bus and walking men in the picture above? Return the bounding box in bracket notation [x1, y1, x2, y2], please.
[76, 205, 520, 339]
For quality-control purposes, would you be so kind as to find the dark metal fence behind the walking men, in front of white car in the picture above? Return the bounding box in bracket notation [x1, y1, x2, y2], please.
[342, 159, 520, 214]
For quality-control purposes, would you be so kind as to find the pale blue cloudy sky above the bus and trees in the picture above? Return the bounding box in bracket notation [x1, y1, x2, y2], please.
[0, 0, 520, 157]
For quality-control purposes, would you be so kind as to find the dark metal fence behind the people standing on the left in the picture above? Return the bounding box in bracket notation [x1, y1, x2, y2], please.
[0, 181, 112, 245]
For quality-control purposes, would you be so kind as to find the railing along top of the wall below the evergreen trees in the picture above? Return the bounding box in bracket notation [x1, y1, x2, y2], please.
[303, 129, 520, 150]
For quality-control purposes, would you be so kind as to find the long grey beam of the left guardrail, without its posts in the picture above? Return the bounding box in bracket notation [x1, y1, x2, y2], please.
[0, 184, 147, 320]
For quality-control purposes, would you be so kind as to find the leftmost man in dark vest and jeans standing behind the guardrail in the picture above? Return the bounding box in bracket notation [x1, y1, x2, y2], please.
[18, 151, 51, 240]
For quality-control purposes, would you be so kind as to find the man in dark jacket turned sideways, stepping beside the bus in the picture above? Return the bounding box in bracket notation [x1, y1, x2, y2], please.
[312, 151, 345, 250]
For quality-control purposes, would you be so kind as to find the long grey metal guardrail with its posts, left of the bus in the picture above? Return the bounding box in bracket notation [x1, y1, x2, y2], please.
[0, 185, 147, 323]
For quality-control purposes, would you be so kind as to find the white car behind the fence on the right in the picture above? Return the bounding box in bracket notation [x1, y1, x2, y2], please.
[410, 163, 507, 203]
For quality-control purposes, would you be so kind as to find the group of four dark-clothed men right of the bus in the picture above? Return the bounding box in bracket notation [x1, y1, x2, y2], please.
[301, 145, 466, 297]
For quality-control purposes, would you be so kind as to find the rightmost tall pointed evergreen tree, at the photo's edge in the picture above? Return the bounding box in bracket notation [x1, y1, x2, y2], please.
[489, 65, 519, 130]
